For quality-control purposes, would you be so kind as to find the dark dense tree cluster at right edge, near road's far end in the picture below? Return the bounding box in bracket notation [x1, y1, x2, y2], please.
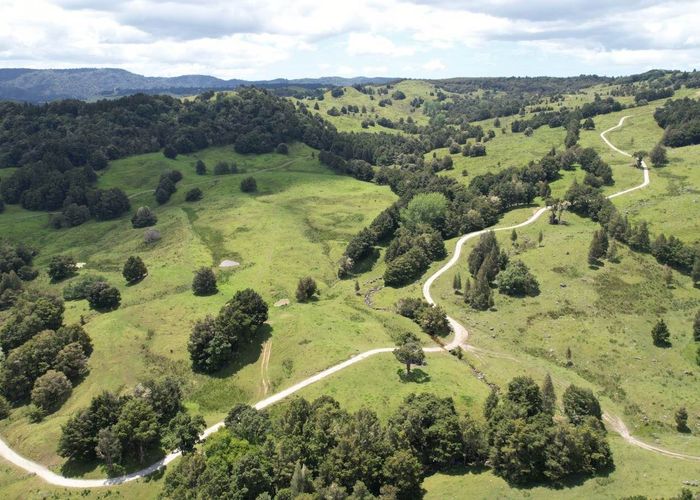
[654, 97, 700, 148]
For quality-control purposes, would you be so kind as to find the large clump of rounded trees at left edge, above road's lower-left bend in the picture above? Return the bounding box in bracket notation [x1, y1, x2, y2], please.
[0, 293, 92, 418]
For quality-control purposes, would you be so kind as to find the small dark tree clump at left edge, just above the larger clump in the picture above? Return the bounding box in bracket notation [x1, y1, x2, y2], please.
[0, 240, 38, 311]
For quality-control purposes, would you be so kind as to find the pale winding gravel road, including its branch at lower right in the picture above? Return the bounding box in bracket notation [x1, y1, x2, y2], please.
[0, 116, 700, 488]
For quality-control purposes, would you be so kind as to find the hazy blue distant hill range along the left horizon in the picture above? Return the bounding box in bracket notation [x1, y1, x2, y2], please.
[0, 68, 395, 102]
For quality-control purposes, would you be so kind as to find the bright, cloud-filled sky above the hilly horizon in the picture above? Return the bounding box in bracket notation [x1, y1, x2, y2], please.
[0, 0, 700, 80]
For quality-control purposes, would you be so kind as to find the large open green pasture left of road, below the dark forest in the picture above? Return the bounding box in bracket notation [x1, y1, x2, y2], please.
[0, 145, 426, 476]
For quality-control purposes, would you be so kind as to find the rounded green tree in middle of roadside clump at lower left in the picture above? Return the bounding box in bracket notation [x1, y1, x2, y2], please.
[114, 398, 160, 463]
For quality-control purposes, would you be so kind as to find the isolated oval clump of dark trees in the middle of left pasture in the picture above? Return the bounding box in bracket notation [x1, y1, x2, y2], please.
[187, 288, 268, 373]
